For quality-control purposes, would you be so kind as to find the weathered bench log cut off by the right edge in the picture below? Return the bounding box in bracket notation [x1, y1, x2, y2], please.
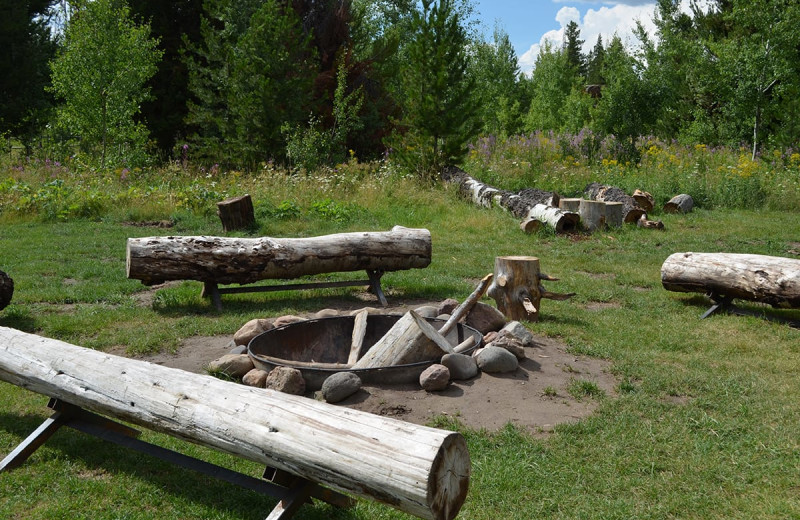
[661, 253, 800, 308]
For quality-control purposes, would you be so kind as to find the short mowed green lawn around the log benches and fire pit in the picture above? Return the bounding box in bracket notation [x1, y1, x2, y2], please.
[0, 172, 800, 520]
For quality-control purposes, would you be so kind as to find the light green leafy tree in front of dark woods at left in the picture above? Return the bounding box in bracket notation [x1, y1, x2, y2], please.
[52, 0, 161, 168]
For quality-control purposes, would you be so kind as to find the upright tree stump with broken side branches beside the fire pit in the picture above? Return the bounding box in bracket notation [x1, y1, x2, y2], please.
[487, 256, 574, 321]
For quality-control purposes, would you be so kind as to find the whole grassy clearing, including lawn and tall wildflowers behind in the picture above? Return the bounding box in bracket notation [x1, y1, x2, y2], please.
[0, 135, 800, 520]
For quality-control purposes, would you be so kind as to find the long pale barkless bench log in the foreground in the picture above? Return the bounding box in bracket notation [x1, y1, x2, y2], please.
[0, 327, 470, 520]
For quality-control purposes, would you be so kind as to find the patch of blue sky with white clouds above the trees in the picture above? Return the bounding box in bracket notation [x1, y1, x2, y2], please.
[475, 0, 664, 73]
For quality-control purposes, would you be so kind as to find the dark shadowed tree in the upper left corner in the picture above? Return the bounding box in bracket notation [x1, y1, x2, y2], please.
[0, 0, 56, 146]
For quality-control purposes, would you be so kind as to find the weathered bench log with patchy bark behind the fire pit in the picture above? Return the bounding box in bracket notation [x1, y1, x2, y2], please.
[126, 226, 431, 285]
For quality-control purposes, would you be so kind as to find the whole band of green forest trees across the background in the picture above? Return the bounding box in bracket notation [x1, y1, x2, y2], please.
[0, 0, 800, 177]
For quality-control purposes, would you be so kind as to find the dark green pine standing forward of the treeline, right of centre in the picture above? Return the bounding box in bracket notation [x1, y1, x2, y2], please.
[395, 0, 478, 179]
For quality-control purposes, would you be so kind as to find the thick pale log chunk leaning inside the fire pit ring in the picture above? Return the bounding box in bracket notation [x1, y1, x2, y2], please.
[353, 311, 453, 369]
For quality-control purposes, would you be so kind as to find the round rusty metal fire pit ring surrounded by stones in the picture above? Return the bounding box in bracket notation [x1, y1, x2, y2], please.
[247, 314, 483, 390]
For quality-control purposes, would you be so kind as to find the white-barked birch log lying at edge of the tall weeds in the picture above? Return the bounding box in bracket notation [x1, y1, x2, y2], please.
[442, 166, 578, 232]
